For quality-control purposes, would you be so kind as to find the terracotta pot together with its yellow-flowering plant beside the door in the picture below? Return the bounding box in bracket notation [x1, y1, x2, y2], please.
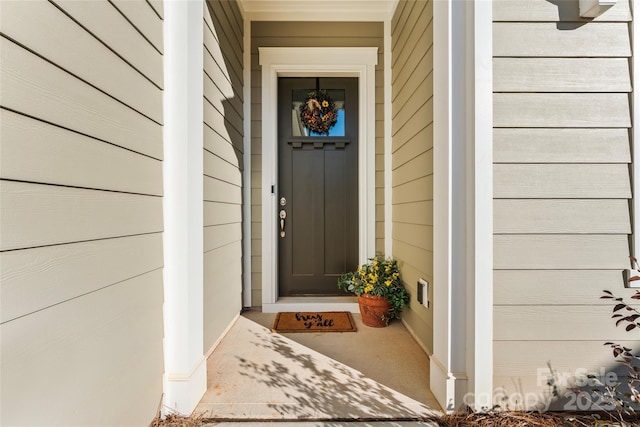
[338, 255, 409, 327]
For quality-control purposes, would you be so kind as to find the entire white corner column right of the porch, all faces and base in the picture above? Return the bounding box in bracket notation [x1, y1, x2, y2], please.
[430, 1, 493, 410]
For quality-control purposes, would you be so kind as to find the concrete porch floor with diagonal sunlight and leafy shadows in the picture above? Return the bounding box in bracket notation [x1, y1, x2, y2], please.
[194, 310, 440, 427]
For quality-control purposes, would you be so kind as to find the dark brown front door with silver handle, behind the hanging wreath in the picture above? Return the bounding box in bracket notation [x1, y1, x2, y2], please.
[277, 78, 358, 296]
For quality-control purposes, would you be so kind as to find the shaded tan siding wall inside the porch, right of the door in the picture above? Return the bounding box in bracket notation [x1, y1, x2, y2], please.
[391, 1, 434, 349]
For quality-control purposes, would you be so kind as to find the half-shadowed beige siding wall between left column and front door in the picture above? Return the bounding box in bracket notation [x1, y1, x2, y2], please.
[203, 1, 243, 351]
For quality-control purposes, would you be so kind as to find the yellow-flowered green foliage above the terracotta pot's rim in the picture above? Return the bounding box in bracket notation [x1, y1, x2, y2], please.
[338, 255, 409, 319]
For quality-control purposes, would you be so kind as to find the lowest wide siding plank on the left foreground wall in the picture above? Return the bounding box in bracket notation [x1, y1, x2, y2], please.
[2, 268, 163, 426]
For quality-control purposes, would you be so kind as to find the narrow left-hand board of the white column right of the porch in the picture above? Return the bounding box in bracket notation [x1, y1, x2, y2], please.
[430, 1, 466, 410]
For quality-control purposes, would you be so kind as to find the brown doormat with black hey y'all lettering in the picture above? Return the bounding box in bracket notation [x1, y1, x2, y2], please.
[271, 311, 358, 332]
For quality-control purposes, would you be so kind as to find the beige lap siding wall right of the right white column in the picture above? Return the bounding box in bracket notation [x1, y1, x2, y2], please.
[493, 0, 633, 408]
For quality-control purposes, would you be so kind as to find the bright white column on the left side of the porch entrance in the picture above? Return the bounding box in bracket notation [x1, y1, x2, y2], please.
[163, 0, 207, 415]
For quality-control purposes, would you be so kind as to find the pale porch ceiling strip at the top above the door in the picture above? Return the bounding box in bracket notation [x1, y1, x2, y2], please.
[239, 0, 398, 22]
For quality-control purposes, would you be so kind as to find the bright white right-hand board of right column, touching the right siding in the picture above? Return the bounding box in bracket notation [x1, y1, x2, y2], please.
[467, 1, 493, 409]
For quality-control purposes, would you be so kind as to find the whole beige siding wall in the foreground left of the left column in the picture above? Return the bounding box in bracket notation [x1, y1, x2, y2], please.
[0, 1, 163, 426]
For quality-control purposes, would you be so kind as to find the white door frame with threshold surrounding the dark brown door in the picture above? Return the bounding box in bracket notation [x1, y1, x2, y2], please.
[258, 47, 378, 313]
